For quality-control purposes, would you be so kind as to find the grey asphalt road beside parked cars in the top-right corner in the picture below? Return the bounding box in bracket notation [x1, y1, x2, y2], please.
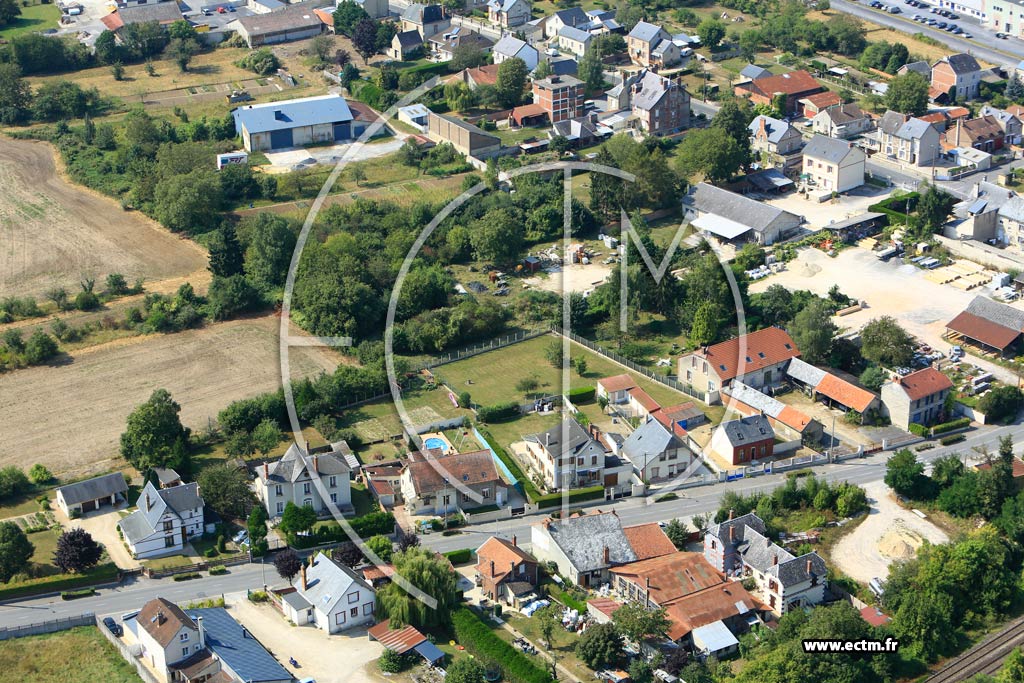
[831, 0, 1024, 66]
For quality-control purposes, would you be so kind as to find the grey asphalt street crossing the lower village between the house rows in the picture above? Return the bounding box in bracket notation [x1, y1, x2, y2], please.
[12, 424, 1024, 627]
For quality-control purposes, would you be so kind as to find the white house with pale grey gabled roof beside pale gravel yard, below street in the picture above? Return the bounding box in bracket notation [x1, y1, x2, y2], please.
[282, 552, 377, 634]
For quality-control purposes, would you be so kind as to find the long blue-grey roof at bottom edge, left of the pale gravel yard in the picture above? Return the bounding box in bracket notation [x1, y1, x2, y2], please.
[185, 607, 293, 683]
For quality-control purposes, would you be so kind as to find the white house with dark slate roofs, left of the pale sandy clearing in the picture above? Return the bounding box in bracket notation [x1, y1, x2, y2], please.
[703, 512, 827, 614]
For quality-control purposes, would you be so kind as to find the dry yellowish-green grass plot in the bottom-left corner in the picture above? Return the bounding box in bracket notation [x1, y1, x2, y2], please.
[0, 627, 141, 683]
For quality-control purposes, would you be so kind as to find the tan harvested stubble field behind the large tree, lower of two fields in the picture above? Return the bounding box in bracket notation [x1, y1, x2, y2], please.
[0, 315, 339, 476]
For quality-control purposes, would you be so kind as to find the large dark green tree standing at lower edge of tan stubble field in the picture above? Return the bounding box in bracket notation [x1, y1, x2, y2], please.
[121, 389, 189, 471]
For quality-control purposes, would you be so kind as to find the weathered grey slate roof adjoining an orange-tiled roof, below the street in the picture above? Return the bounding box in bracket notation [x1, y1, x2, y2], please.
[541, 512, 637, 572]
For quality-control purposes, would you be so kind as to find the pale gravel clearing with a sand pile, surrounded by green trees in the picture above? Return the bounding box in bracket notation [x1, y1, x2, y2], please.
[831, 481, 949, 584]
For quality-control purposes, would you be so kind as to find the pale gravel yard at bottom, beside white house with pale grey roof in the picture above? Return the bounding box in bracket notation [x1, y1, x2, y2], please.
[224, 593, 384, 683]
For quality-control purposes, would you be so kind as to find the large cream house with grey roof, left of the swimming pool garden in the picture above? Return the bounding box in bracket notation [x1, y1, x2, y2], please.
[254, 441, 352, 519]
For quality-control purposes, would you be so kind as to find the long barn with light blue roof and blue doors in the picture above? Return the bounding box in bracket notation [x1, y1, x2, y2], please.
[232, 95, 358, 152]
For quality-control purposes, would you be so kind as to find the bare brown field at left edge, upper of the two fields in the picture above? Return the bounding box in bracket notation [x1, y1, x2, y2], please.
[0, 136, 206, 298]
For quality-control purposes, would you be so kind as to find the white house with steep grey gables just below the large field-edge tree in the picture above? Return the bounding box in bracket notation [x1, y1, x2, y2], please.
[118, 481, 204, 559]
